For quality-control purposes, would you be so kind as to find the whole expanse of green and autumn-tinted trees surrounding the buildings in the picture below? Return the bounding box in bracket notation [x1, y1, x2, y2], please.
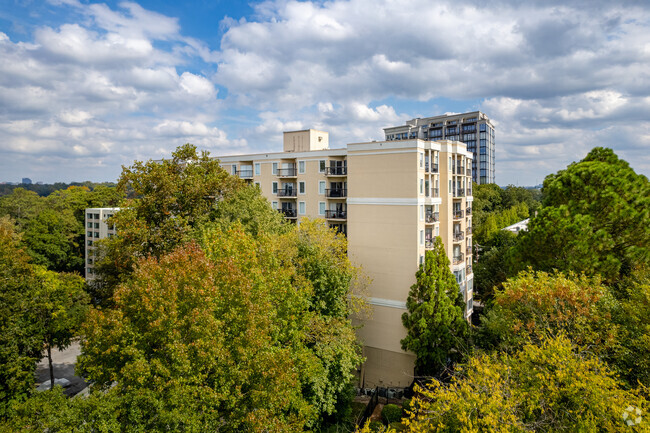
[0, 145, 650, 432]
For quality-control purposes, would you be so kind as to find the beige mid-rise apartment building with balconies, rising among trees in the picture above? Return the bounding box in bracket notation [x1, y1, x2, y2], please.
[220, 129, 473, 387]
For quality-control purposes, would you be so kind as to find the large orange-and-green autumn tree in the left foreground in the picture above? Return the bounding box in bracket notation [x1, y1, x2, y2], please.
[80, 223, 361, 431]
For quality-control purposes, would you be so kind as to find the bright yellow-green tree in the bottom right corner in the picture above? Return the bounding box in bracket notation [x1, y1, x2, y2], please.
[403, 336, 647, 433]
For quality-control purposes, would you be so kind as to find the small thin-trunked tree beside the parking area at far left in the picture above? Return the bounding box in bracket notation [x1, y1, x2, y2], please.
[31, 267, 89, 388]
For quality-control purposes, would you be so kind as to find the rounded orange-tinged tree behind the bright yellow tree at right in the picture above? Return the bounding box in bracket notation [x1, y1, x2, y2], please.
[477, 271, 619, 358]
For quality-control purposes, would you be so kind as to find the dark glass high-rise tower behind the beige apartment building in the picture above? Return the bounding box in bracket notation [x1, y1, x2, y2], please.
[384, 111, 496, 184]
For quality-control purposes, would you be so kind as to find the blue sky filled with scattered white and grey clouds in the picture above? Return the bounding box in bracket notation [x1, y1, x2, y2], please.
[0, 0, 650, 185]
